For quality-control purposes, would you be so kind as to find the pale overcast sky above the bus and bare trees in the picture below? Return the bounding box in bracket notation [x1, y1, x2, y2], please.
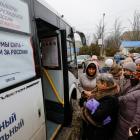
[46, 0, 140, 41]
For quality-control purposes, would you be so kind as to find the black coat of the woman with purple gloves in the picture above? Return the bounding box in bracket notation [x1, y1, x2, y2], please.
[81, 96, 118, 140]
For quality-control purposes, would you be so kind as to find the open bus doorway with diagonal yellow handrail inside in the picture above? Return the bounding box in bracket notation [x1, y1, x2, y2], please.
[36, 19, 64, 139]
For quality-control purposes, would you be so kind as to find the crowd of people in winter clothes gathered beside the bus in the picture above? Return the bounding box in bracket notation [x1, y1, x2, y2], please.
[78, 55, 140, 140]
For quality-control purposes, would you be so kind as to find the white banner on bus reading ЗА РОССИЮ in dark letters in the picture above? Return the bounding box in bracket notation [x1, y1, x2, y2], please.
[0, 31, 35, 89]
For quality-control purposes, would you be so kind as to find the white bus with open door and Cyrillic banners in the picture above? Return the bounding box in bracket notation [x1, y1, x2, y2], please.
[0, 0, 85, 140]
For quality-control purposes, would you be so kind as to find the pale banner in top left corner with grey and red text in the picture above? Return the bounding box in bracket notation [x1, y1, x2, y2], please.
[0, 0, 30, 33]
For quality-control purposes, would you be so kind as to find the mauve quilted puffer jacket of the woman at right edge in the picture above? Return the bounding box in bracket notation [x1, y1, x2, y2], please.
[114, 83, 140, 140]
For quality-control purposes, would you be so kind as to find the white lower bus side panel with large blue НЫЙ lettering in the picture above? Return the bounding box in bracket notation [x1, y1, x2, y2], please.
[0, 79, 46, 140]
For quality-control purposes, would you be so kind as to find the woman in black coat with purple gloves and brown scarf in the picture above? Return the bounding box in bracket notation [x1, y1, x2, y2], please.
[82, 73, 118, 140]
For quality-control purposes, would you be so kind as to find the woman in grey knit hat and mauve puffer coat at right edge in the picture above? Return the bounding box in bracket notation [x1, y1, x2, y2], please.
[114, 62, 140, 140]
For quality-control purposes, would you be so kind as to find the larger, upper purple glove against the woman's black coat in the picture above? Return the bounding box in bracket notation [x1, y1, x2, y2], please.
[85, 99, 100, 114]
